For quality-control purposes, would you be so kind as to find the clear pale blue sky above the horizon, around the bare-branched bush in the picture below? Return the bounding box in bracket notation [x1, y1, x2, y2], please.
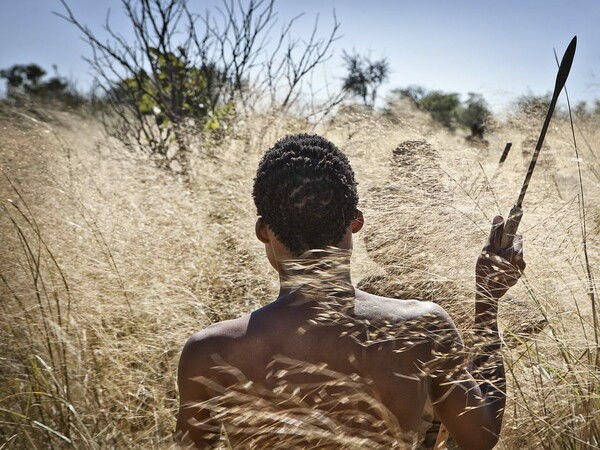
[0, 0, 600, 109]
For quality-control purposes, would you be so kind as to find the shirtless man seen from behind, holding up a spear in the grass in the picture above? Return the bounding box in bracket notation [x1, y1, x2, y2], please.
[177, 134, 525, 449]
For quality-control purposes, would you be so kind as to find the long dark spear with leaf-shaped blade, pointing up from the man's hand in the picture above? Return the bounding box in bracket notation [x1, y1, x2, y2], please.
[501, 36, 577, 248]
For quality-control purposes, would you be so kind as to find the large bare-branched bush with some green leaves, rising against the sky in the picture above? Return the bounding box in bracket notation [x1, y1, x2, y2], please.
[56, 0, 340, 176]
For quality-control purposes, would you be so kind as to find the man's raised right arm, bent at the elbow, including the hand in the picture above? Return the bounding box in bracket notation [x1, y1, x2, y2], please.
[431, 216, 525, 449]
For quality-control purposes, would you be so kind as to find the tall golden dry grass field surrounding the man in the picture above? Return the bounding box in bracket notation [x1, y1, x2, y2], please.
[0, 101, 600, 449]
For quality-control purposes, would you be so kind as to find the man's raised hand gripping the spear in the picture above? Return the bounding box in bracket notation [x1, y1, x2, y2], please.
[475, 216, 526, 306]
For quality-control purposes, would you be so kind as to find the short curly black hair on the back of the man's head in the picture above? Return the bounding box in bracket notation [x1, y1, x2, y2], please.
[252, 134, 358, 256]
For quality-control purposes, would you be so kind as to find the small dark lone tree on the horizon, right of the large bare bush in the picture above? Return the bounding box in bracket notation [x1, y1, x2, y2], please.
[342, 51, 390, 108]
